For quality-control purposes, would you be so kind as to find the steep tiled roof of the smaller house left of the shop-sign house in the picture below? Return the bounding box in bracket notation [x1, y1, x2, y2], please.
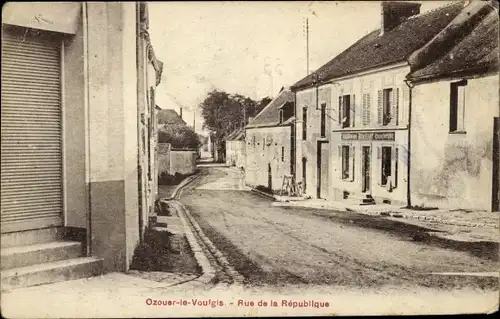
[246, 88, 295, 128]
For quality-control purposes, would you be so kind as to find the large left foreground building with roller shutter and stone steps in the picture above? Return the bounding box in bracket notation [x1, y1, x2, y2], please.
[1, 2, 162, 288]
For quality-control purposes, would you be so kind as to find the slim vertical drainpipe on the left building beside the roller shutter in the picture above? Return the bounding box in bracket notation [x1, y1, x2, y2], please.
[82, 2, 92, 257]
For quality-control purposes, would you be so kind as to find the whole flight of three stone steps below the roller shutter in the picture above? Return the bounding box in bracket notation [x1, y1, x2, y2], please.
[0, 228, 103, 290]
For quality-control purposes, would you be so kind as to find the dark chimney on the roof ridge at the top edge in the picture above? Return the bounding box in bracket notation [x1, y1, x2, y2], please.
[380, 1, 421, 35]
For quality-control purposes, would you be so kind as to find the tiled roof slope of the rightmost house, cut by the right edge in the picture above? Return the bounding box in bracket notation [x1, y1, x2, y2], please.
[409, 10, 499, 80]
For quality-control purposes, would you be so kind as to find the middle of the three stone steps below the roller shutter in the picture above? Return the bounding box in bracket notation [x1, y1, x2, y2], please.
[0, 241, 82, 270]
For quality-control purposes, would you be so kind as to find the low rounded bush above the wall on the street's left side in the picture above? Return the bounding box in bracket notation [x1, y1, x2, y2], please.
[158, 124, 201, 149]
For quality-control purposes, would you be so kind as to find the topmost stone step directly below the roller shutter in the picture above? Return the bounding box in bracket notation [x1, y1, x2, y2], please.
[1, 227, 64, 249]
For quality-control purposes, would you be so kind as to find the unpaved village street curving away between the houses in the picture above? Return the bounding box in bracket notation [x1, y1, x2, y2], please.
[181, 165, 498, 289]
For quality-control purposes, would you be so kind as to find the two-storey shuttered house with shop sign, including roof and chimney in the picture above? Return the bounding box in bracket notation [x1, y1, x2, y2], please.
[292, 2, 486, 205]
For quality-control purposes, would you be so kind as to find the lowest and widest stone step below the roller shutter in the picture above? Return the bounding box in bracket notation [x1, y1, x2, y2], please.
[0, 257, 103, 290]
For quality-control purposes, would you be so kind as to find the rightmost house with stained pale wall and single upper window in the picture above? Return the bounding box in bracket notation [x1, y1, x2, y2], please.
[408, 2, 500, 211]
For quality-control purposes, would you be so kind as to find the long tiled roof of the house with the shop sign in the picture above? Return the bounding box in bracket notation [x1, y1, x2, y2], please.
[292, 1, 464, 90]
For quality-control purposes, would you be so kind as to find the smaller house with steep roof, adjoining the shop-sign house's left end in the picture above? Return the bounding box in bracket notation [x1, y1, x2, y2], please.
[245, 88, 295, 191]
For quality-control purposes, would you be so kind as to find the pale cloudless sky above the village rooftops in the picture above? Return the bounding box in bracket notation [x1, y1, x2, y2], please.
[149, 1, 450, 131]
